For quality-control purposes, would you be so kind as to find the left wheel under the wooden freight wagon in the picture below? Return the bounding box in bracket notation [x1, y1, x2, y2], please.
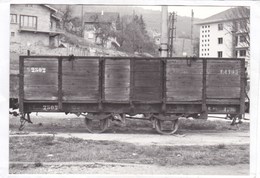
[85, 117, 109, 133]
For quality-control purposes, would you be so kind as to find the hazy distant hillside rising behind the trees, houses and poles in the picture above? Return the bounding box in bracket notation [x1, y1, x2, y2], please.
[52, 4, 199, 38]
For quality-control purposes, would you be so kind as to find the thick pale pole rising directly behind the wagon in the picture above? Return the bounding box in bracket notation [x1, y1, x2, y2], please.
[160, 6, 168, 57]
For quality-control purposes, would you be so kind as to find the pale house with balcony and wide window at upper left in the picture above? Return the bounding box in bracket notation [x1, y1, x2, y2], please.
[10, 4, 62, 49]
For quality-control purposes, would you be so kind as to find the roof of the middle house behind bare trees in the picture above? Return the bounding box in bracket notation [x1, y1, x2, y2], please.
[84, 12, 119, 22]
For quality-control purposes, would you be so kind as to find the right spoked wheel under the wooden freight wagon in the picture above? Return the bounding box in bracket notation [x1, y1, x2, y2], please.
[155, 119, 179, 135]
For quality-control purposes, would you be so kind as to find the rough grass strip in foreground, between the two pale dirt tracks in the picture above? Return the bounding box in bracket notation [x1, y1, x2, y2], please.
[9, 136, 249, 165]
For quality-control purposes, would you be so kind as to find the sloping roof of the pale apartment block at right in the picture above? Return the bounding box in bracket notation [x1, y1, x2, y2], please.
[196, 6, 250, 25]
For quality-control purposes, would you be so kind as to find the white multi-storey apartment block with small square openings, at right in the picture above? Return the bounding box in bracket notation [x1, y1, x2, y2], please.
[196, 7, 250, 62]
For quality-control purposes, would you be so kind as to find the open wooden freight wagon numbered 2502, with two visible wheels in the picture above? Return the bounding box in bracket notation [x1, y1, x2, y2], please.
[16, 56, 246, 134]
